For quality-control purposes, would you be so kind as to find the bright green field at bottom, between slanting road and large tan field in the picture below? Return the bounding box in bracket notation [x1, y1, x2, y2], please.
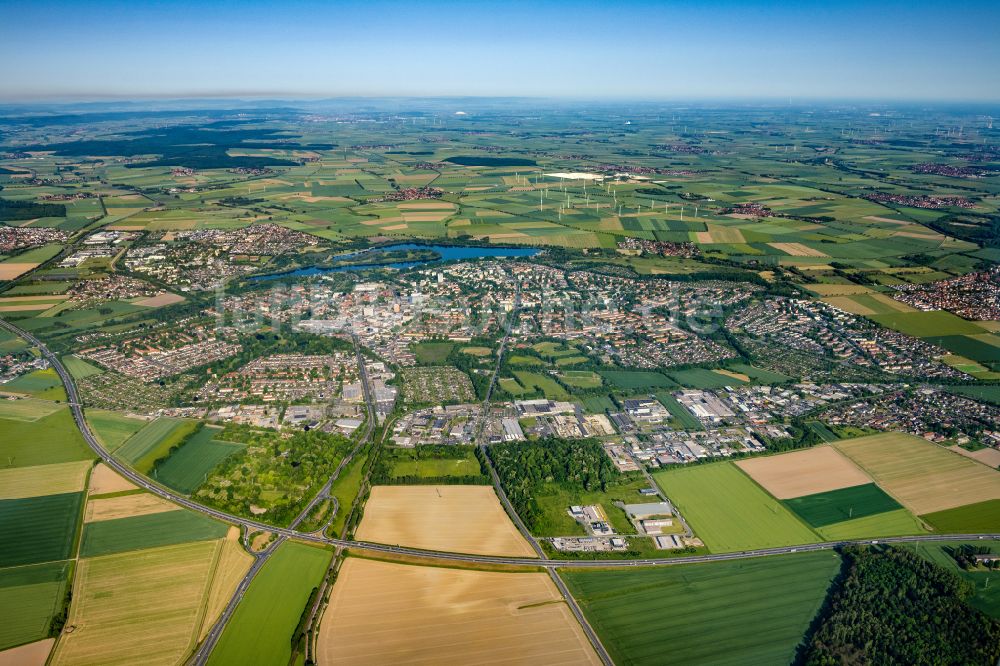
[208, 542, 332, 666]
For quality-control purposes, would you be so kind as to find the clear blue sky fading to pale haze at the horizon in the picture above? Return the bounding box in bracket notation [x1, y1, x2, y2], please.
[0, 0, 1000, 101]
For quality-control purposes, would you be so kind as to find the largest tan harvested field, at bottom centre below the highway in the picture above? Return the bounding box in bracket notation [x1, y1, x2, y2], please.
[317, 557, 600, 665]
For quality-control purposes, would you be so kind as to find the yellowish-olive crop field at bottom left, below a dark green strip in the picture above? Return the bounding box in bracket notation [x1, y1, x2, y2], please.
[51, 541, 220, 665]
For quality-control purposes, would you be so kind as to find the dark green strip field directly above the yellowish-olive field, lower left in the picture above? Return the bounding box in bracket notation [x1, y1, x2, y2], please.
[80, 509, 229, 557]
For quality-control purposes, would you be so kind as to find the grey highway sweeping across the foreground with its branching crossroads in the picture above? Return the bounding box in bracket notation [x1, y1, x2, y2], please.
[0, 319, 1000, 664]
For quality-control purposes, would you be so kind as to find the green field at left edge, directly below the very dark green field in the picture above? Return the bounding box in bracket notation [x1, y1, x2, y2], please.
[0, 562, 71, 650]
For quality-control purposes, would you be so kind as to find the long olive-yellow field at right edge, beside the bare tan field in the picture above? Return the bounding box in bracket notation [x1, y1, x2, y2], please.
[833, 433, 1000, 516]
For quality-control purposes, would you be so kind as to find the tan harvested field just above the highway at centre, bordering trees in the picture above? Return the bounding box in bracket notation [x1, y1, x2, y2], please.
[355, 486, 535, 557]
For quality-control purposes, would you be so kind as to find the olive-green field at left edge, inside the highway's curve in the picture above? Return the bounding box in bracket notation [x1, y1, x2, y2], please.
[0, 407, 94, 467]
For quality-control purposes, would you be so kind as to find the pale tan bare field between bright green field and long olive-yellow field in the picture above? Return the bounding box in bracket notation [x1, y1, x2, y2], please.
[736, 446, 871, 499]
